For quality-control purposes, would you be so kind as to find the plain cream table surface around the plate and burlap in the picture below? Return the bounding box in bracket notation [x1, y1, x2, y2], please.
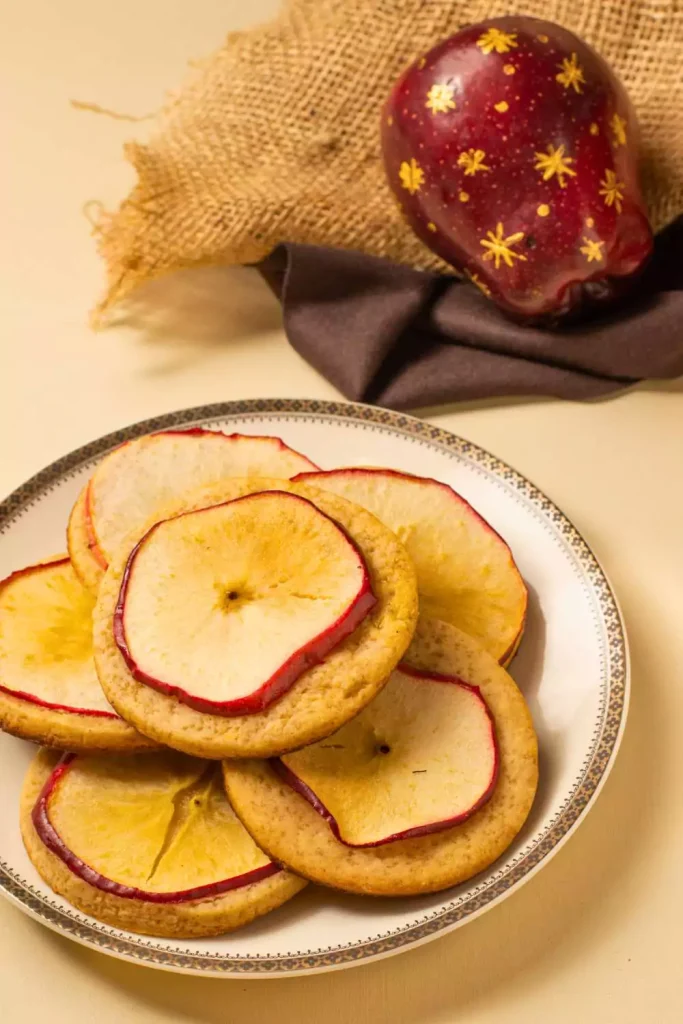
[0, 0, 683, 1024]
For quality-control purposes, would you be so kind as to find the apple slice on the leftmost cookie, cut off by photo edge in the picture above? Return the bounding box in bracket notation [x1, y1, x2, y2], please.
[0, 557, 119, 720]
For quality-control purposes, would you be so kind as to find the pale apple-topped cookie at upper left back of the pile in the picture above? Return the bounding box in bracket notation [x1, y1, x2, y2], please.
[67, 427, 317, 591]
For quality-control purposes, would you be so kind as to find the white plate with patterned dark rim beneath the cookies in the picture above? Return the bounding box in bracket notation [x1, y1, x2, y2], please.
[0, 399, 629, 977]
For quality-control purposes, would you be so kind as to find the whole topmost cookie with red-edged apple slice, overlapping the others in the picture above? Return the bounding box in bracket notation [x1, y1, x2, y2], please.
[94, 479, 417, 758]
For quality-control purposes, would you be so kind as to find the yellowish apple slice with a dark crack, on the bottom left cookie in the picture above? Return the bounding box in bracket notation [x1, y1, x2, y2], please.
[32, 752, 282, 903]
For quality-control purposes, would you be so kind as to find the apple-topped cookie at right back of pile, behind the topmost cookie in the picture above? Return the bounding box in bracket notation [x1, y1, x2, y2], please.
[295, 468, 526, 665]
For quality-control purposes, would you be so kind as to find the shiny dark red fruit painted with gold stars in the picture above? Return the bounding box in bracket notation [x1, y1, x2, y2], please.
[382, 16, 652, 319]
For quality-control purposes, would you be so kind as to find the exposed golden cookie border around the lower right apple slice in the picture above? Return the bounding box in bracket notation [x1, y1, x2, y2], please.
[223, 620, 538, 896]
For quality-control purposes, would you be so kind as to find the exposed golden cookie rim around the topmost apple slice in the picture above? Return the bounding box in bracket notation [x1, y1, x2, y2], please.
[93, 478, 418, 759]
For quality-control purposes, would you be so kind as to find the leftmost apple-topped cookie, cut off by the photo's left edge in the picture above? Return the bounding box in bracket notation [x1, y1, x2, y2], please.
[0, 556, 156, 751]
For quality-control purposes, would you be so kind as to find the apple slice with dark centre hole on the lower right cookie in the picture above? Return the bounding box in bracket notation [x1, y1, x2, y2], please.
[270, 666, 499, 847]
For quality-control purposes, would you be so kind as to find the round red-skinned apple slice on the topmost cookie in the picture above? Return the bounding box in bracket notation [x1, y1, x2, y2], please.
[114, 490, 376, 716]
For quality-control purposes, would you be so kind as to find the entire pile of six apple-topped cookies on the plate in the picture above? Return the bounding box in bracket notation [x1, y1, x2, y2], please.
[0, 429, 538, 937]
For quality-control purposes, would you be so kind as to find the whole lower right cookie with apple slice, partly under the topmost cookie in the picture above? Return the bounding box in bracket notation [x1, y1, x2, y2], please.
[223, 620, 538, 896]
